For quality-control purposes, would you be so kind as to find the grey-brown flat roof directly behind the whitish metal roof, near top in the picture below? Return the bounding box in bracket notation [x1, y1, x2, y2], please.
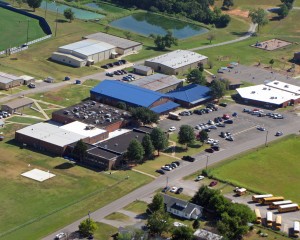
[84, 32, 142, 49]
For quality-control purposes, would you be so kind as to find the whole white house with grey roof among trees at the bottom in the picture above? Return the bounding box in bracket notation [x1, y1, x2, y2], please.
[162, 194, 203, 219]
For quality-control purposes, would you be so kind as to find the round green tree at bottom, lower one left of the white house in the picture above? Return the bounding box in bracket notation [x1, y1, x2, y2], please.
[147, 210, 171, 236]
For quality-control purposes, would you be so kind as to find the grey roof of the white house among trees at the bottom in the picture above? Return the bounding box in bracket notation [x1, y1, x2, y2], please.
[162, 194, 203, 215]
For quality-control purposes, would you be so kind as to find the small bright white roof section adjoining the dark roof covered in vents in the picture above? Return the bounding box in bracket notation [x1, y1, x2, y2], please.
[60, 121, 106, 137]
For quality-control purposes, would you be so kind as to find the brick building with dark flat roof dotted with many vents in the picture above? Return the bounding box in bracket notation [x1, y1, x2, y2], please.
[52, 100, 130, 132]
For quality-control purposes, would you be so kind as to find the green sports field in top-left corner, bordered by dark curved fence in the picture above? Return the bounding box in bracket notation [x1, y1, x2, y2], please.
[0, 7, 46, 51]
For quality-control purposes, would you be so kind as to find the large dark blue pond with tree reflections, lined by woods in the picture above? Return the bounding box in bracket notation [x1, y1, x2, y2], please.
[110, 13, 208, 39]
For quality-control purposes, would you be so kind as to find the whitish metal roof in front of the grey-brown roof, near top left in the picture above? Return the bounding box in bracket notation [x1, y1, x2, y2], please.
[58, 39, 115, 56]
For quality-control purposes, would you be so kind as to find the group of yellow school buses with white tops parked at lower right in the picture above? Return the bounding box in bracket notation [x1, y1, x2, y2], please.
[252, 194, 300, 238]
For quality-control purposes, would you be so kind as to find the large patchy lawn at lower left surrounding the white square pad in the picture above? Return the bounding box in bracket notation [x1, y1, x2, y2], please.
[0, 135, 151, 240]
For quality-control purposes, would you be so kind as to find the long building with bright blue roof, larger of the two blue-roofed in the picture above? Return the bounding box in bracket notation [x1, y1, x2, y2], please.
[90, 80, 179, 114]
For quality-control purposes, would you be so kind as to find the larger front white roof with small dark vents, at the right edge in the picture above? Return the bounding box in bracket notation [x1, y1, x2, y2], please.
[237, 84, 300, 105]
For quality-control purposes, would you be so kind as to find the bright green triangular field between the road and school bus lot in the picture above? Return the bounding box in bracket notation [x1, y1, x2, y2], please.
[212, 135, 300, 203]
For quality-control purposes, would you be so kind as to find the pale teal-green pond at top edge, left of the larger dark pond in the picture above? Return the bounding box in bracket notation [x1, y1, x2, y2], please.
[40, 1, 105, 20]
